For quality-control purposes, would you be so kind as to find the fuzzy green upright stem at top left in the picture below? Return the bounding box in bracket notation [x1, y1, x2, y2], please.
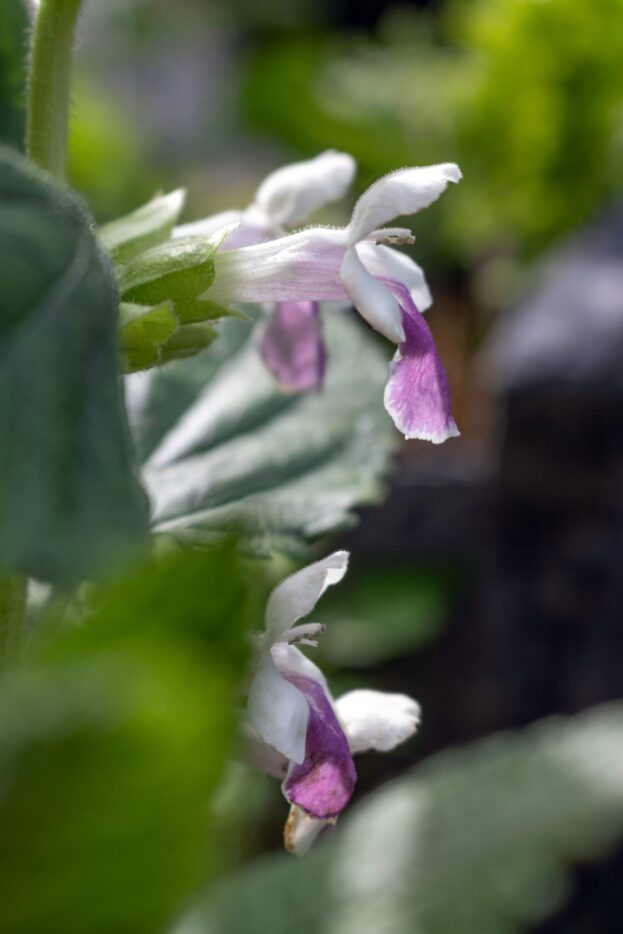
[26, 0, 81, 179]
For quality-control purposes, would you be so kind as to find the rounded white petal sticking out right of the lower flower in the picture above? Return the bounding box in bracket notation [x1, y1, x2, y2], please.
[335, 690, 420, 753]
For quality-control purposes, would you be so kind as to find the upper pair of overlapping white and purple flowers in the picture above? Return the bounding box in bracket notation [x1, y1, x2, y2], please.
[175, 152, 461, 443]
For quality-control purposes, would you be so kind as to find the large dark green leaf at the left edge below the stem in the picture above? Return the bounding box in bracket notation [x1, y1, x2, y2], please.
[0, 149, 146, 579]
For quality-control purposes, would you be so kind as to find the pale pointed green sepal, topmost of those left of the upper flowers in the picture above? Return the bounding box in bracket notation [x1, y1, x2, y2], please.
[98, 188, 186, 263]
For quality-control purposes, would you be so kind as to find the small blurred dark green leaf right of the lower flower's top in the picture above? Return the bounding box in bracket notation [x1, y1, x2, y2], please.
[320, 566, 451, 668]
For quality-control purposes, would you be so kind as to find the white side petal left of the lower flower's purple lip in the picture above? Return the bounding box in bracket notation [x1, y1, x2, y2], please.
[247, 652, 309, 763]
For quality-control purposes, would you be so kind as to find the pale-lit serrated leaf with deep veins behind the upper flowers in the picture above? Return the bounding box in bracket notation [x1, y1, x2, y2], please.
[128, 310, 396, 554]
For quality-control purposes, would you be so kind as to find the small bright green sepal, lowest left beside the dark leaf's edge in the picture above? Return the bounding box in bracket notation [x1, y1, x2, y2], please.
[119, 302, 178, 373]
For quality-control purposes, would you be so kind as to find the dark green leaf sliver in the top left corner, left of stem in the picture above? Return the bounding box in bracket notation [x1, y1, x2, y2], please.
[0, 0, 28, 147]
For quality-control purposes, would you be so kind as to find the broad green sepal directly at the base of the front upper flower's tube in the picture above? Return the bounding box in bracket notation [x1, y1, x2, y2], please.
[119, 237, 216, 305]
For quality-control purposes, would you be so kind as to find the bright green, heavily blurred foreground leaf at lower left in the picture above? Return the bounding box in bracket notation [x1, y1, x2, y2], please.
[0, 543, 254, 934]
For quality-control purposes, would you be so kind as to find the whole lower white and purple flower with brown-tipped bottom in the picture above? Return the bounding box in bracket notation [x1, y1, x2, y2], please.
[248, 551, 420, 855]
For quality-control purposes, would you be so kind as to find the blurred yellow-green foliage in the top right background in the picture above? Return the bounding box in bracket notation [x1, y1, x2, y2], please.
[246, 0, 623, 262]
